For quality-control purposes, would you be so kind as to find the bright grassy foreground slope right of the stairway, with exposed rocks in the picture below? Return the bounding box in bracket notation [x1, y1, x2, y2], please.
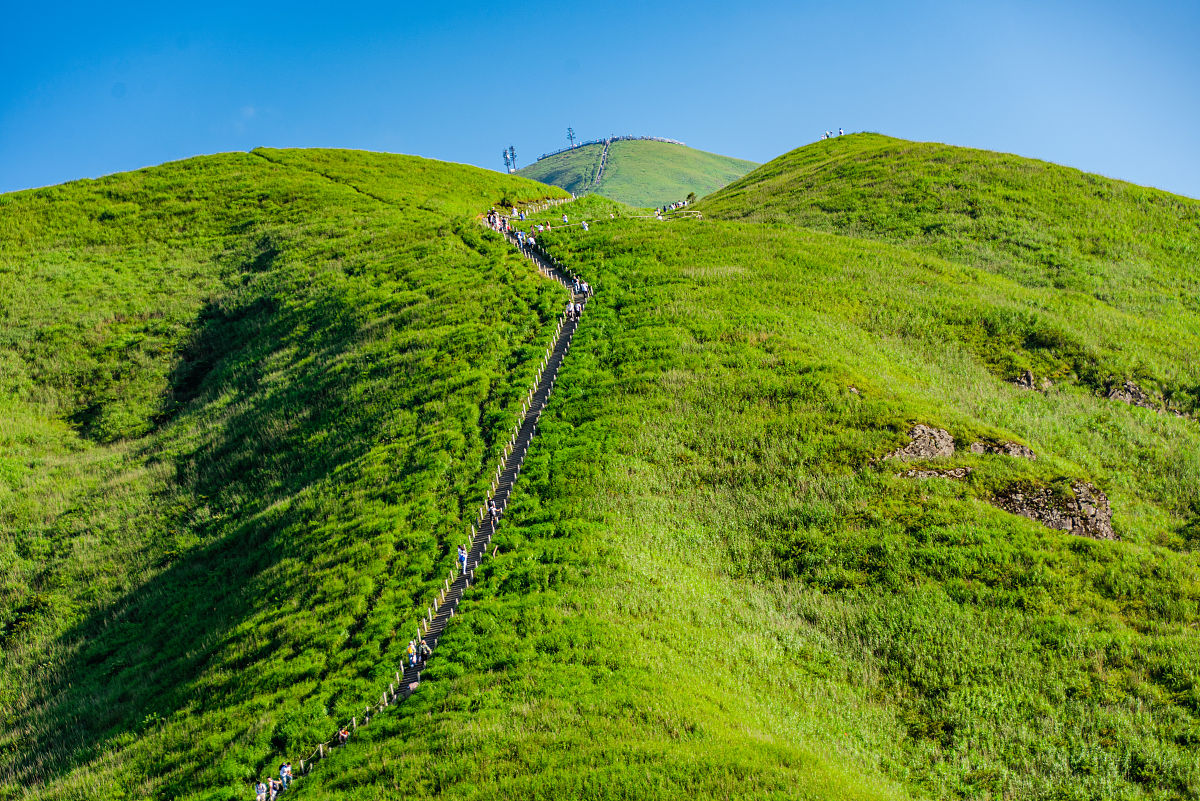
[301, 175, 1200, 800]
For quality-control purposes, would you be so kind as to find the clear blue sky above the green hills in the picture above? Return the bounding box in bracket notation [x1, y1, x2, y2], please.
[0, 0, 1200, 197]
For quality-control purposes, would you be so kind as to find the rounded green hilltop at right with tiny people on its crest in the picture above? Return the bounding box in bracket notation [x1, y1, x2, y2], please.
[700, 133, 1200, 318]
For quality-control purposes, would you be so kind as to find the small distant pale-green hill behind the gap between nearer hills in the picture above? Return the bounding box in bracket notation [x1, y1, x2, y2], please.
[517, 140, 757, 207]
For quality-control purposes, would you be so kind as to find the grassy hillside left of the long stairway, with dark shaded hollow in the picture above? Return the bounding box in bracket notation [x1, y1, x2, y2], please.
[0, 150, 563, 800]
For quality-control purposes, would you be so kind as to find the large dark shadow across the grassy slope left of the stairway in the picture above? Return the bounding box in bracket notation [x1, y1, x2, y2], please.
[11, 268, 398, 791]
